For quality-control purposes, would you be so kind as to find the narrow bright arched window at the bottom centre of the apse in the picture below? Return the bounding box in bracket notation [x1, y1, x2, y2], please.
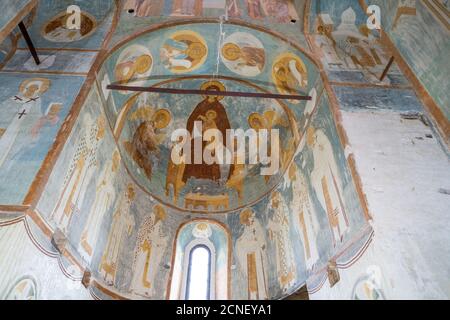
[186, 245, 212, 300]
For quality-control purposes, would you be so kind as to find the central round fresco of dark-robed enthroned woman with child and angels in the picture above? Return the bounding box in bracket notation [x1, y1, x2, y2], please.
[117, 79, 298, 212]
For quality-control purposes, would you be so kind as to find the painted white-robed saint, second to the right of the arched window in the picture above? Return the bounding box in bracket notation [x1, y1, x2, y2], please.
[268, 193, 296, 291]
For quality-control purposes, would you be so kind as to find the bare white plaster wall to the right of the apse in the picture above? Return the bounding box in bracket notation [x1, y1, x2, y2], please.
[311, 111, 450, 299]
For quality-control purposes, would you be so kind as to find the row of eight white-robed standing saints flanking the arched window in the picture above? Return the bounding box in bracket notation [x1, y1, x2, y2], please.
[44, 102, 349, 299]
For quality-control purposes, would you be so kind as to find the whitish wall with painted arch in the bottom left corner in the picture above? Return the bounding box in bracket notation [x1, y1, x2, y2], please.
[0, 212, 91, 300]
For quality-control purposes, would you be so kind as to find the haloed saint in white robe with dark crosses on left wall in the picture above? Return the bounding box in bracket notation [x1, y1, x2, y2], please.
[0, 78, 50, 168]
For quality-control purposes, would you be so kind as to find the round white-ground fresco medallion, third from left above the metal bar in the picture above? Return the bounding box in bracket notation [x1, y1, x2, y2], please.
[221, 32, 266, 77]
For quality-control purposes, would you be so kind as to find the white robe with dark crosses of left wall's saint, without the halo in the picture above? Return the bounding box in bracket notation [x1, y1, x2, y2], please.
[0, 89, 44, 168]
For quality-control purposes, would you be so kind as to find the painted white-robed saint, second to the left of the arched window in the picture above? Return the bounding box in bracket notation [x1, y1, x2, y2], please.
[100, 191, 135, 285]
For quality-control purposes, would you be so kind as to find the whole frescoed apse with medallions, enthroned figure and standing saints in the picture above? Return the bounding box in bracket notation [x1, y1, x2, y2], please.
[24, 15, 374, 299]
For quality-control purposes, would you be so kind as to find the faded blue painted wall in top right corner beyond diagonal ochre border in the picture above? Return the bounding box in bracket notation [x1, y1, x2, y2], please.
[373, 0, 450, 122]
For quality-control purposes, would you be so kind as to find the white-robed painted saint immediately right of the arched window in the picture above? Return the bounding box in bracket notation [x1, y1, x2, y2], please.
[236, 210, 269, 300]
